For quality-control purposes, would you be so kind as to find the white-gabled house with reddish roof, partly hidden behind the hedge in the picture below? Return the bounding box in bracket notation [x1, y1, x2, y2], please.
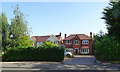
[32, 32, 62, 46]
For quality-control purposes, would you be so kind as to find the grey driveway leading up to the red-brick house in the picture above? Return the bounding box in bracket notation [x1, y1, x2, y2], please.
[63, 55, 96, 65]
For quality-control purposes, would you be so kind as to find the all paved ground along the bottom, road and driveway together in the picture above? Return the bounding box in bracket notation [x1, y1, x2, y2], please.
[0, 55, 120, 72]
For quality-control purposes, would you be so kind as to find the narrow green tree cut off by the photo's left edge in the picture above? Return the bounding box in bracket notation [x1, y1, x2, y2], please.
[0, 13, 10, 50]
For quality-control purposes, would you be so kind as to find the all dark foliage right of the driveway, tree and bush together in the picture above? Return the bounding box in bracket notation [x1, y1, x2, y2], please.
[94, 1, 120, 61]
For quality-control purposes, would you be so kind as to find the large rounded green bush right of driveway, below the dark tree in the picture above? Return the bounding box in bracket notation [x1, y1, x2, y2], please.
[95, 36, 120, 61]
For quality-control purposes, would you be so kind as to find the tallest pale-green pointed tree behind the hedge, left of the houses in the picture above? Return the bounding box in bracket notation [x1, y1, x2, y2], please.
[10, 5, 28, 46]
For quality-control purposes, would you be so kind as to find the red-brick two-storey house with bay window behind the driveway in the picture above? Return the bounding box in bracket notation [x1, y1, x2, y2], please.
[63, 32, 93, 55]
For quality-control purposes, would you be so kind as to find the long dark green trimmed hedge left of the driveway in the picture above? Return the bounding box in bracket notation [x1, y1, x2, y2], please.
[2, 43, 64, 61]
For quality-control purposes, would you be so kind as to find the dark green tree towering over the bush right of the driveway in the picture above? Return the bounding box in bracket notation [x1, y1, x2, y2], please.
[102, 1, 120, 40]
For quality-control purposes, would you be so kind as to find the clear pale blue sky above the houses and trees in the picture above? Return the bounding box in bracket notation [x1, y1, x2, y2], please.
[2, 2, 108, 37]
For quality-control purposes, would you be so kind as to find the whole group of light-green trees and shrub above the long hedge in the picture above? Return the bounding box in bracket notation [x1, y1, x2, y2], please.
[0, 5, 33, 51]
